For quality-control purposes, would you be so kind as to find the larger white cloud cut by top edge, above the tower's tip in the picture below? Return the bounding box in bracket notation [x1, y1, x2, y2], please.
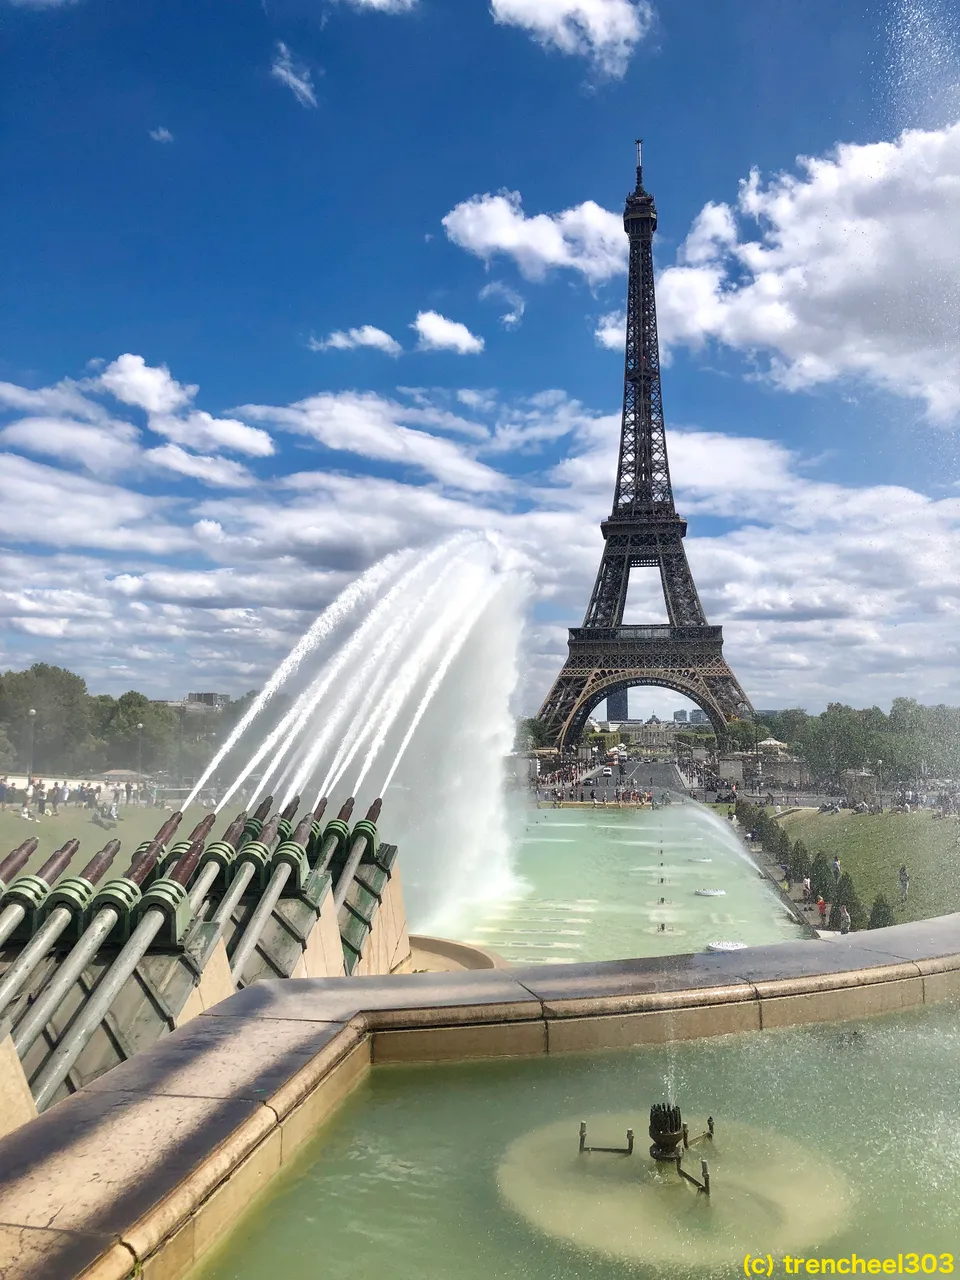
[490, 0, 653, 76]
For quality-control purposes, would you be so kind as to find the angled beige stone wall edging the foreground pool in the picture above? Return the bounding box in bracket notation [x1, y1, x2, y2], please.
[0, 915, 960, 1280]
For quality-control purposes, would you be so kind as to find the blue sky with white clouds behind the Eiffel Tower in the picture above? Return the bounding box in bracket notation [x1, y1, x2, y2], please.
[0, 0, 960, 710]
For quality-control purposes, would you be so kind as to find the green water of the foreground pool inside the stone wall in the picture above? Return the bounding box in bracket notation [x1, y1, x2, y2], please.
[192, 1005, 960, 1280]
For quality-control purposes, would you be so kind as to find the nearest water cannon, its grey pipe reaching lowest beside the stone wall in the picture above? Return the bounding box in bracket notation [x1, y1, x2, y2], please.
[33, 828, 209, 1111]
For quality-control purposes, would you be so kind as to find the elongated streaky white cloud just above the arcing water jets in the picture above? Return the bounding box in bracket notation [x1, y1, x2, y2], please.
[237, 392, 508, 493]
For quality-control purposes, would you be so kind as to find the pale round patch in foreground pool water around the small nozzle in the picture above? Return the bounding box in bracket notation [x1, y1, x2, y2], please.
[497, 1103, 854, 1274]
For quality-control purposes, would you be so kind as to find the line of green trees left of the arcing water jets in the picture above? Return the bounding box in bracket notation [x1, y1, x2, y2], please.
[0, 662, 256, 778]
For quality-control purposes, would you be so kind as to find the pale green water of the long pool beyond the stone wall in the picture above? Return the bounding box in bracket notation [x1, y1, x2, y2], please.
[435, 803, 803, 964]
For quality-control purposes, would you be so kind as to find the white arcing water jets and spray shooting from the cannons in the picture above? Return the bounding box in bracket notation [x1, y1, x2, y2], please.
[206, 534, 527, 929]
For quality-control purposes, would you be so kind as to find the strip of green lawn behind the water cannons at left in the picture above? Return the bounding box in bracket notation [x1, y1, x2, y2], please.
[0, 805, 229, 878]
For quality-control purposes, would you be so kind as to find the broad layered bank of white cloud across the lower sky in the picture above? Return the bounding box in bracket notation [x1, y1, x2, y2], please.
[0, 353, 960, 710]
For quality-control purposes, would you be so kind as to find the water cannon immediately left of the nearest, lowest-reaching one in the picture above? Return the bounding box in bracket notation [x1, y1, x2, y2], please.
[13, 812, 183, 1057]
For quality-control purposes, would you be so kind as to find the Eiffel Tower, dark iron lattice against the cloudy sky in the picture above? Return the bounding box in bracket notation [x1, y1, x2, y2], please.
[538, 142, 753, 746]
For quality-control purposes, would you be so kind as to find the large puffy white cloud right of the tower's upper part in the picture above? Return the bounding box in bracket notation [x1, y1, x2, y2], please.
[658, 123, 960, 422]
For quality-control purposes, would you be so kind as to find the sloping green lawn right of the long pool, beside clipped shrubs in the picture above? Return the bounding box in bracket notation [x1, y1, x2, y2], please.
[781, 809, 960, 922]
